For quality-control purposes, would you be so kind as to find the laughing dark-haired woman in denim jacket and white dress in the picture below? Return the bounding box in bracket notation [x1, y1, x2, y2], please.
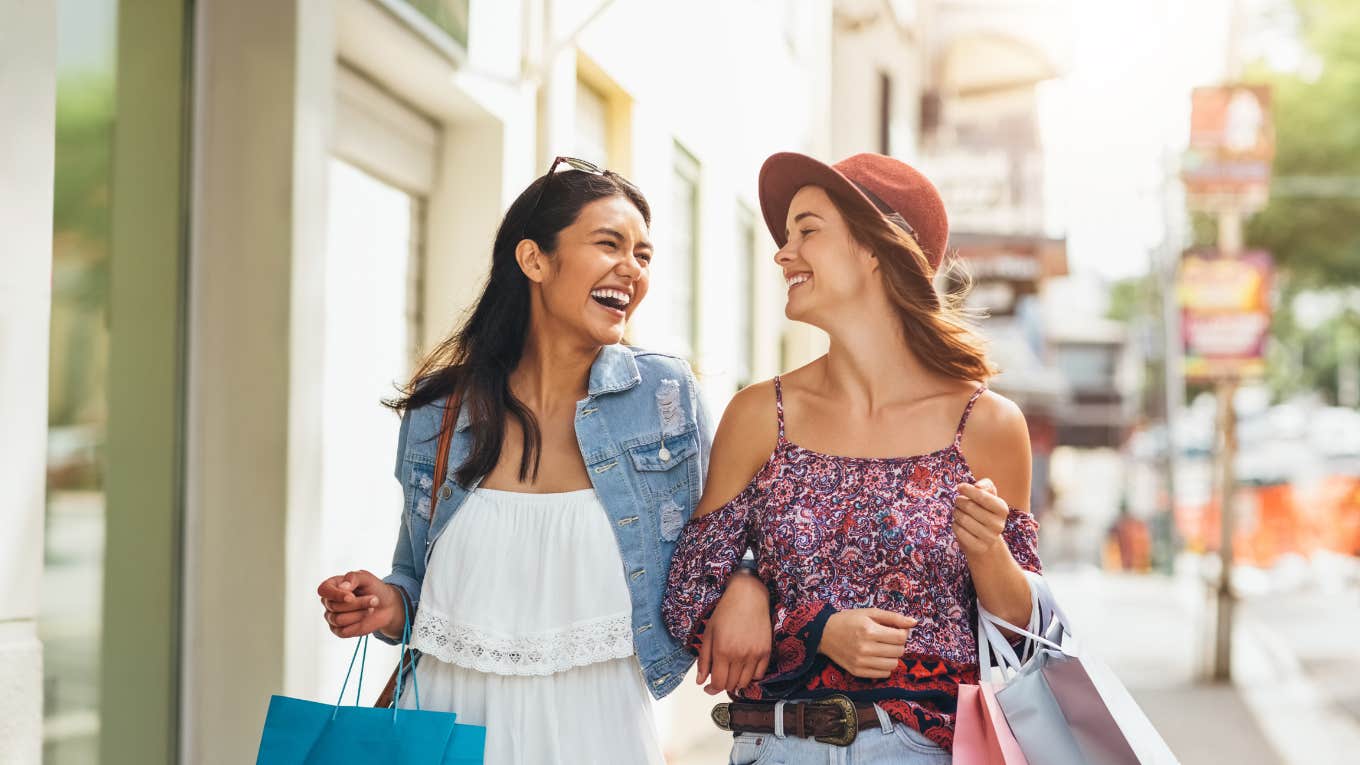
[318, 158, 770, 765]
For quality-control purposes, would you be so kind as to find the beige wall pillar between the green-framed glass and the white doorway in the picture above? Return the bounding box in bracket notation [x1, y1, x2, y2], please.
[181, 0, 335, 764]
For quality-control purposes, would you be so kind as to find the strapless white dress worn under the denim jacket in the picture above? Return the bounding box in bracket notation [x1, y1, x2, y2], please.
[400, 489, 664, 765]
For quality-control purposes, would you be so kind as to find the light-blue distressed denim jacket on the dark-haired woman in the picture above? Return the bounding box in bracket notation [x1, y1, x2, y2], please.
[375, 346, 713, 698]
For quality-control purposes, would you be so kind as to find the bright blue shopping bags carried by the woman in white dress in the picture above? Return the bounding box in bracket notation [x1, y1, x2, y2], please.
[256, 619, 487, 765]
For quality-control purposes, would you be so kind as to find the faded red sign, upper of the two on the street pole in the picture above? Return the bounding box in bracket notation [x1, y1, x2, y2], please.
[1180, 84, 1274, 211]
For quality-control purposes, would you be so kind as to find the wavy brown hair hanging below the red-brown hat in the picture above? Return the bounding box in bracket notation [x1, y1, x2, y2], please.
[828, 185, 998, 383]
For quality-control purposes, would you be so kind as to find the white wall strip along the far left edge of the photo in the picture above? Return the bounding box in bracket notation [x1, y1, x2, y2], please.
[0, 3, 57, 765]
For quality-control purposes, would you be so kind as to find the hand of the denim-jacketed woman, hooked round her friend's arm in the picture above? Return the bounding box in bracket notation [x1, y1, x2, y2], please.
[695, 569, 774, 696]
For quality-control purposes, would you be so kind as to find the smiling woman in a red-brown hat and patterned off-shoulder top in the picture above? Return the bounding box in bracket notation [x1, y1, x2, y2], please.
[662, 154, 1040, 765]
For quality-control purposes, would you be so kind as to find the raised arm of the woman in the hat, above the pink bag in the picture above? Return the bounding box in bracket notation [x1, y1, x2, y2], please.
[953, 393, 1042, 626]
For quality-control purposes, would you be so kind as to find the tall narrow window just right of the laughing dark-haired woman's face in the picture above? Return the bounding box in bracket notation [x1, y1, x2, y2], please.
[669, 144, 699, 359]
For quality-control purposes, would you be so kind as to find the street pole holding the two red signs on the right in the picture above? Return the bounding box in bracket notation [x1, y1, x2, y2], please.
[1212, 206, 1242, 682]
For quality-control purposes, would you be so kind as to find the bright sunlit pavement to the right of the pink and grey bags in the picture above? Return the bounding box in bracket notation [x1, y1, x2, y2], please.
[1049, 570, 1360, 765]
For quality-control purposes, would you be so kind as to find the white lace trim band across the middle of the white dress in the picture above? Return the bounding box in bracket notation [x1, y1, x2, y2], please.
[411, 606, 634, 675]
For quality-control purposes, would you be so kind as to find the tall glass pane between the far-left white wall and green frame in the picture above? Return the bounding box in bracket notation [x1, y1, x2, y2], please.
[38, 0, 118, 764]
